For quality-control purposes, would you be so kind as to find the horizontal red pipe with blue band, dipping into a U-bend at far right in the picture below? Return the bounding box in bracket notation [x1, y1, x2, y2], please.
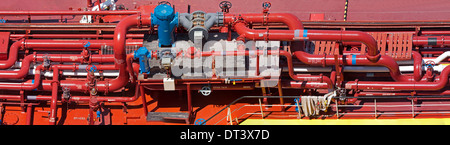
[294, 51, 423, 81]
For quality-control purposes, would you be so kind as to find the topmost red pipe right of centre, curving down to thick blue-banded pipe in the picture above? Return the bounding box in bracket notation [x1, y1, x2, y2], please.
[223, 13, 303, 30]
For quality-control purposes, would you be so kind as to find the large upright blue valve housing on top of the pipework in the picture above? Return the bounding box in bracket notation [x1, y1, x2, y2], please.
[151, 4, 178, 47]
